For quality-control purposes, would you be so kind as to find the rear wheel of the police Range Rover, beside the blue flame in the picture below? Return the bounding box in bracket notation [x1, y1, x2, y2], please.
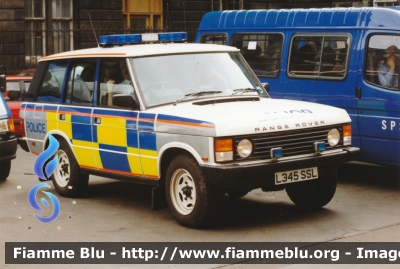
[51, 140, 89, 197]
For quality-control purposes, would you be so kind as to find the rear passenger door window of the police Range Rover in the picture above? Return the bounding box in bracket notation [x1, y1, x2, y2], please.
[65, 59, 96, 105]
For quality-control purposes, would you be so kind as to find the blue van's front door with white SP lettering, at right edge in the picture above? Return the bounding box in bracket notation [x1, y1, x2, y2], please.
[357, 31, 400, 166]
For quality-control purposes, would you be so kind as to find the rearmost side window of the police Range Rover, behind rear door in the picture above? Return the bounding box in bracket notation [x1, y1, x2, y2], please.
[37, 60, 68, 103]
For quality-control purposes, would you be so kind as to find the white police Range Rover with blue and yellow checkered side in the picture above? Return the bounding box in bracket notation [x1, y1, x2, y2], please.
[19, 33, 359, 227]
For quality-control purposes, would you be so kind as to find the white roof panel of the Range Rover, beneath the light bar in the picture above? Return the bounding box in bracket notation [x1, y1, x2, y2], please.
[41, 43, 238, 61]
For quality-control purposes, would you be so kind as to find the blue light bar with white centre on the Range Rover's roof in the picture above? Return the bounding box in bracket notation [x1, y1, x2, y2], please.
[99, 32, 187, 47]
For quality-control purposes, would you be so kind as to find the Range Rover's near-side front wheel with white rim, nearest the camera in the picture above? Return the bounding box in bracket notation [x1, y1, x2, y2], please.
[165, 154, 222, 228]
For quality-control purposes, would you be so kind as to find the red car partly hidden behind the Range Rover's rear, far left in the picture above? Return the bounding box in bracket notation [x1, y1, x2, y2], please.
[3, 76, 32, 137]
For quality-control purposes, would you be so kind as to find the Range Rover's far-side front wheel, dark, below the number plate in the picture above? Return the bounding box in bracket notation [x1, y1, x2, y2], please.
[286, 169, 337, 209]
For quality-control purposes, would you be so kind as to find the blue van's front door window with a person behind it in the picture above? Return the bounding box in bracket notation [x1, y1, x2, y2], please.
[365, 35, 400, 90]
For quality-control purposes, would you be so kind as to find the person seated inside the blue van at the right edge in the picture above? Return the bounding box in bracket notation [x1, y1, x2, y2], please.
[378, 45, 400, 89]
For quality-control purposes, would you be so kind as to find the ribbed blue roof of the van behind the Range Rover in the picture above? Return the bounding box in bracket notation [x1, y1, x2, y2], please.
[198, 7, 400, 31]
